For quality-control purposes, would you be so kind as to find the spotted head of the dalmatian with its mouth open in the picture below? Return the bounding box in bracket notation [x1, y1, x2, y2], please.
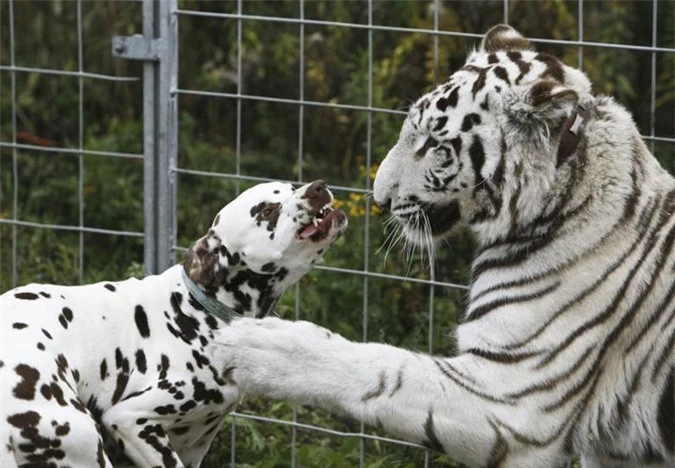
[183, 181, 347, 314]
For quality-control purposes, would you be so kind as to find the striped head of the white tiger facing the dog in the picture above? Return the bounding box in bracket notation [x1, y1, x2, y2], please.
[374, 25, 592, 244]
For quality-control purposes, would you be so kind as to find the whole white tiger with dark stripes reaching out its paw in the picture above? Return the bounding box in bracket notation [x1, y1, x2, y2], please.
[218, 25, 675, 468]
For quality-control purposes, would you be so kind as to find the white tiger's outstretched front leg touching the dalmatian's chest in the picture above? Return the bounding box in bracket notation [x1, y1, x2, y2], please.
[216, 318, 564, 467]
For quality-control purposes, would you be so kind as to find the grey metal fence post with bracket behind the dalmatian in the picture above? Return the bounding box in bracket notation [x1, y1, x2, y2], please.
[113, 0, 178, 274]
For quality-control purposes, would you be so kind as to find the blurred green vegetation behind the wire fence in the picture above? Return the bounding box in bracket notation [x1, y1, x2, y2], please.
[0, 0, 675, 468]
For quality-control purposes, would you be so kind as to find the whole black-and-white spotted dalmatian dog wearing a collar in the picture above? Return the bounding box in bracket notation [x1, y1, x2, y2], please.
[0, 181, 347, 468]
